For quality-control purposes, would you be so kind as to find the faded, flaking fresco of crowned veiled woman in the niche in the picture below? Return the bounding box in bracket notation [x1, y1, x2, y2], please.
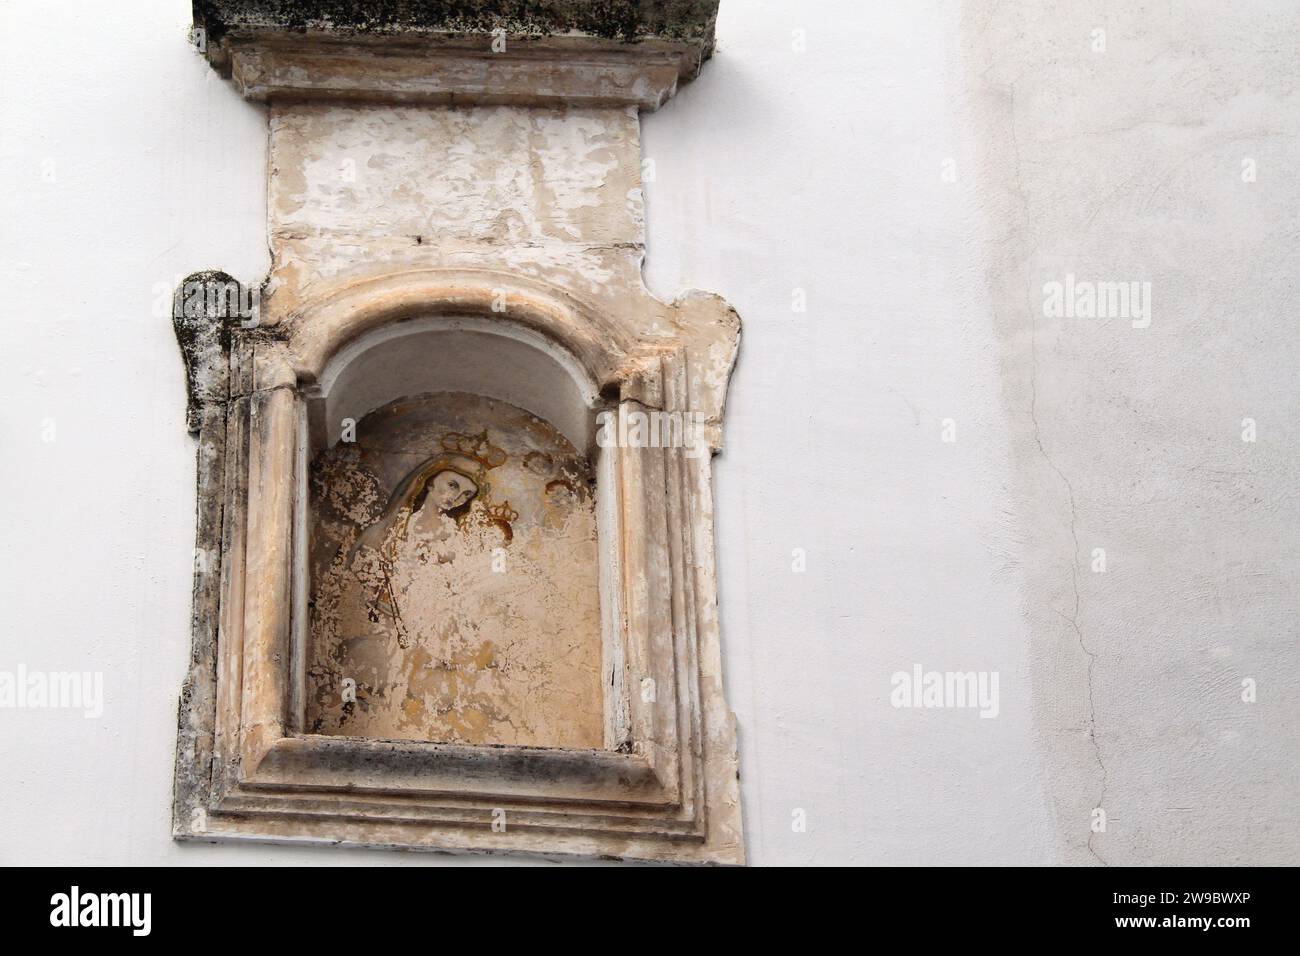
[306, 392, 603, 748]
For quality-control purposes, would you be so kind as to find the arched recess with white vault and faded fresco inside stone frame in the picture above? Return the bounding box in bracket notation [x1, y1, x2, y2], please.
[294, 313, 624, 749]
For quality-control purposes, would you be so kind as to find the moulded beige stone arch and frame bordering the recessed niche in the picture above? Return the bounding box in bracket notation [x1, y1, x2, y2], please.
[177, 271, 735, 861]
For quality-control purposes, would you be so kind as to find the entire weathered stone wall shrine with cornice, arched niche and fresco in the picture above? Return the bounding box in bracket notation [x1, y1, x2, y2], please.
[173, 0, 744, 864]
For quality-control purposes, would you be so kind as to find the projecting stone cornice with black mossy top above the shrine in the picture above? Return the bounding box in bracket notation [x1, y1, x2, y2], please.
[194, 0, 718, 109]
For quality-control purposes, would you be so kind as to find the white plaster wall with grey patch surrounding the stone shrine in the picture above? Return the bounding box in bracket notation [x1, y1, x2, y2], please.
[0, 0, 1300, 865]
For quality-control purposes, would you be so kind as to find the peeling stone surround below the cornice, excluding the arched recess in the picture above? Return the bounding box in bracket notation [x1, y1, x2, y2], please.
[174, 4, 744, 864]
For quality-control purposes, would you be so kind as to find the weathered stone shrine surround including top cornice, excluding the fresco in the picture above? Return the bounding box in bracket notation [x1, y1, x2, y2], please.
[173, 3, 744, 864]
